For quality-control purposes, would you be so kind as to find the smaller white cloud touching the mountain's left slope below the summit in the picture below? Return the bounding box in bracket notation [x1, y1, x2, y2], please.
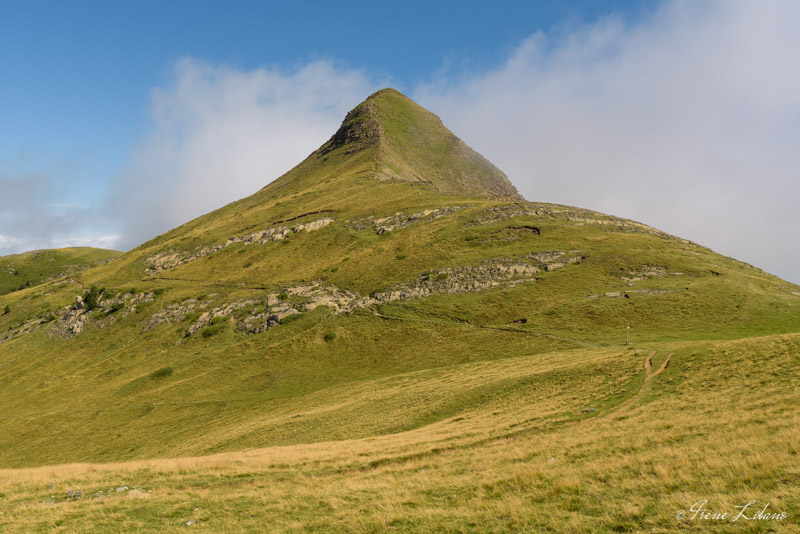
[109, 59, 377, 251]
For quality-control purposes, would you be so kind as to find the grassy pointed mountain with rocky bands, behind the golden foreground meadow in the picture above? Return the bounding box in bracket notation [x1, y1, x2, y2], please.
[0, 89, 800, 466]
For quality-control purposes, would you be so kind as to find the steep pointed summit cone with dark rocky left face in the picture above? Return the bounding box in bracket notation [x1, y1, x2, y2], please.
[315, 88, 522, 200]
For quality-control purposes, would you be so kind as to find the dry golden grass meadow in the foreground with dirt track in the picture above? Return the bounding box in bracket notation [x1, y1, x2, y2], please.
[0, 335, 800, 533]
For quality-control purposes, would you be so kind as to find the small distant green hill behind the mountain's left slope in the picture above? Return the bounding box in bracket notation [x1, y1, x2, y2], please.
[0, 247, 121, 295]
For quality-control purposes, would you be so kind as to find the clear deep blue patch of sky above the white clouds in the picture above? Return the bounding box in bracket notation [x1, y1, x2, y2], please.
[0, 1, 642, 202]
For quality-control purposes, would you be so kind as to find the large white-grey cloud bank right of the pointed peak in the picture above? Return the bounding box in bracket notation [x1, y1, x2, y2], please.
[415, 0, 800, 282]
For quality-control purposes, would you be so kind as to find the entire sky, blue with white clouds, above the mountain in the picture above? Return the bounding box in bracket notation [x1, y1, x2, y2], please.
[0, 0, 800, 282]
